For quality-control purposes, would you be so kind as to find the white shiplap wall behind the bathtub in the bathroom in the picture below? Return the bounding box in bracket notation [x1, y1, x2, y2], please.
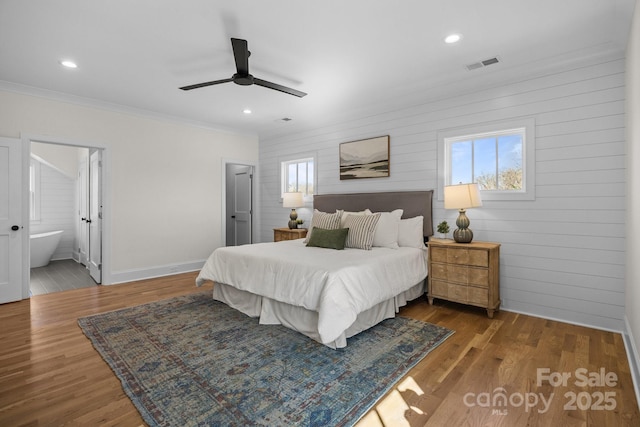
[31, 163, 77, 260]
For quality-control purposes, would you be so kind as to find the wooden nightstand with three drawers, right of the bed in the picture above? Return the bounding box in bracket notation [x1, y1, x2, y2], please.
[428, 239, 500, 318]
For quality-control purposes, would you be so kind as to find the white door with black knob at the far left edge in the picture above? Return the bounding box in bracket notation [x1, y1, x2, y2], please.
[0, 138, 24, 303]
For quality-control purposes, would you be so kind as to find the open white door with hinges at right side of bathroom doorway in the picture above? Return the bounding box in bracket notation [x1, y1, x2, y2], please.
[87, 150, 102, 283]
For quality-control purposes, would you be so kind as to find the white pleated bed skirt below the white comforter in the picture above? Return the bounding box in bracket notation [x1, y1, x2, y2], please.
[213, 279, 426, 348]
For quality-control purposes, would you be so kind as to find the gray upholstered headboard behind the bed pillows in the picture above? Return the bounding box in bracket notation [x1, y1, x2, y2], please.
[313, 190, 433, 236]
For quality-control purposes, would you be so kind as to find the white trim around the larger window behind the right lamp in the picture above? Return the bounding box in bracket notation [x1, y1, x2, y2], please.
[438, 118, 536, 201]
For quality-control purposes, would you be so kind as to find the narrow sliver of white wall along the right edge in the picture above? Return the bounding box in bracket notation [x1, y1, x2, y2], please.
[625, 2, 640, 401]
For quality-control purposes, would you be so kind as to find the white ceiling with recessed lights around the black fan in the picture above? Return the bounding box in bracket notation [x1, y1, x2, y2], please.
[0, 0, 635, 135]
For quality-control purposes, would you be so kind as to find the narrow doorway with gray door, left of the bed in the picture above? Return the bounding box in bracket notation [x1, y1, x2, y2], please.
[225, 163, 253, 246]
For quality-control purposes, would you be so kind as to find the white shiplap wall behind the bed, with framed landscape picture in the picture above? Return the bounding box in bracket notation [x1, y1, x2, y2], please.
[259, 57, 625, 331]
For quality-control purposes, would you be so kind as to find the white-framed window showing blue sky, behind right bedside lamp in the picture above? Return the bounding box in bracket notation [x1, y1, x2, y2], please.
[439, 120, 535, 200]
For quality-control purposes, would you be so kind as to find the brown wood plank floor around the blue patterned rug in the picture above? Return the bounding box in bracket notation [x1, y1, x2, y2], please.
[0, 273, 640, 427]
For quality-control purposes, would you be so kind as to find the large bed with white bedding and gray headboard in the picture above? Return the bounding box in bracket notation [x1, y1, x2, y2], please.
[196, 190, 433, 348]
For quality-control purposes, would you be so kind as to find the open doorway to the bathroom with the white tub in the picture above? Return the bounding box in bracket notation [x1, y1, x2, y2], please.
[29, 139, 103, 295]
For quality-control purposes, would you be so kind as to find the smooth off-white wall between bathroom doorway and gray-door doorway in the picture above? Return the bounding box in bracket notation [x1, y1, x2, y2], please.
[0, 91, 258, 282]
